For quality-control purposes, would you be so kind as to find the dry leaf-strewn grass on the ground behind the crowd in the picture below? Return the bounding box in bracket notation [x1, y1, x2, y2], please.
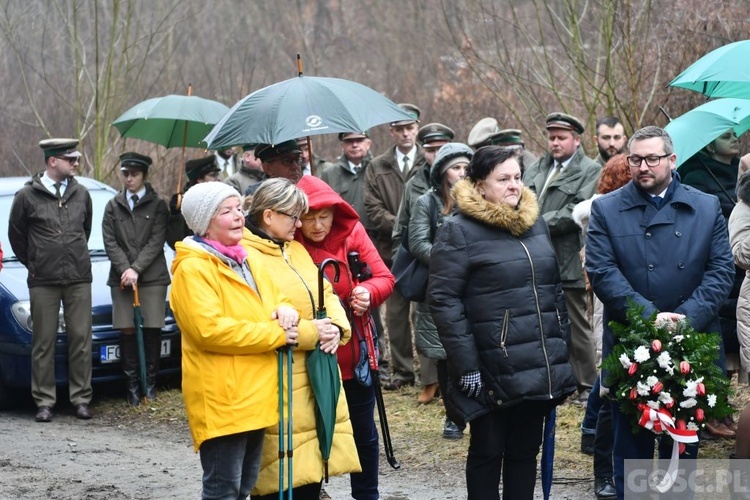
[91, 378, 750, 476]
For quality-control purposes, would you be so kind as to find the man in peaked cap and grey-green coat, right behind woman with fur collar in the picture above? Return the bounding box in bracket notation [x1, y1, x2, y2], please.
[523, 112, 601, 405]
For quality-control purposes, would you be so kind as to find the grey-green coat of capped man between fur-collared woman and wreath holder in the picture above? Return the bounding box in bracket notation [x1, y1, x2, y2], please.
[523, 146, 601, 288]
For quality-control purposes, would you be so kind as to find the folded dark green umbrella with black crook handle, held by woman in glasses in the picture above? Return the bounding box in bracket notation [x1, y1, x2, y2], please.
[306, 259, 341, 482]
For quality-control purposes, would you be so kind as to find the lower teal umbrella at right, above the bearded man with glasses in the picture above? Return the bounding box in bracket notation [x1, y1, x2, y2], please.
[664, 98, 750, 167]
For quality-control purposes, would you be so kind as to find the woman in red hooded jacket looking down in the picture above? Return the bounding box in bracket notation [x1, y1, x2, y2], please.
[295, 175, 395, 500]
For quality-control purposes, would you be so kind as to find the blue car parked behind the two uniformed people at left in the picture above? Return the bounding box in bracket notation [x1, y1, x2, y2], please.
[0, 177, 181, 407]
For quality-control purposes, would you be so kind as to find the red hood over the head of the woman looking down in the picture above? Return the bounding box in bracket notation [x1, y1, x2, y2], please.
[294, 175, 359, 249]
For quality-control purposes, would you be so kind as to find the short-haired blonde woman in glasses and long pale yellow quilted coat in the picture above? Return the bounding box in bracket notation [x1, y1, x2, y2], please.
[242, 178, 360, 500]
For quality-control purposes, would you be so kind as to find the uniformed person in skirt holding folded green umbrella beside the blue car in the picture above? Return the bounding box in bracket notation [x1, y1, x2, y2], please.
[102, 152, 170, 406]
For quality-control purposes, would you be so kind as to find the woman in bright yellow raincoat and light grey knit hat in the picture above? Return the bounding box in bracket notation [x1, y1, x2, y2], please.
[170, 182, 300, 499]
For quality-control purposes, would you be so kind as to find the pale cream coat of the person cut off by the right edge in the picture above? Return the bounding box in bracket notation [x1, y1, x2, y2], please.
[729, 176, 750, 373]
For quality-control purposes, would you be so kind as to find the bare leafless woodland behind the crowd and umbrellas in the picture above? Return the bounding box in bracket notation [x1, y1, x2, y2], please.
[0, 0, 750, 197]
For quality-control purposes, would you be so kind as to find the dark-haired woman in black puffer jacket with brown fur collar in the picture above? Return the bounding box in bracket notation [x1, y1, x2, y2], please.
[428, 146, 576, 500]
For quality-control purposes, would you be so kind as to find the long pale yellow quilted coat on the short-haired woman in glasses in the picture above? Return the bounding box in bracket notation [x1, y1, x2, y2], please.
[242, 229, 360, 495]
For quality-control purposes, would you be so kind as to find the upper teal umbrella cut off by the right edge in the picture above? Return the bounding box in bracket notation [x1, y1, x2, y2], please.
[669, 40, 750, 99]
